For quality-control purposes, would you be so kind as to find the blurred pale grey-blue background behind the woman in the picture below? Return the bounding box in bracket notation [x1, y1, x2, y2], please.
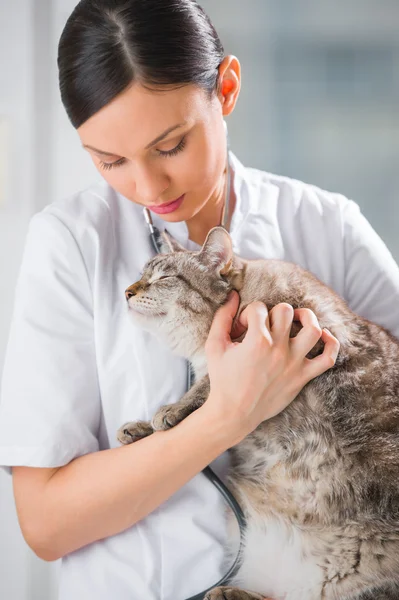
[0, 0, 399, 600]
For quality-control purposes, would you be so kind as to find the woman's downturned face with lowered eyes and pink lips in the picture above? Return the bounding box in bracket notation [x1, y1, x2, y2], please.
[78, 83, 231, 222]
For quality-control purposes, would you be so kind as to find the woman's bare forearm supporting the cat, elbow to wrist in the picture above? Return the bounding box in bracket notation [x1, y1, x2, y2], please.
[34, 403, 239, 561]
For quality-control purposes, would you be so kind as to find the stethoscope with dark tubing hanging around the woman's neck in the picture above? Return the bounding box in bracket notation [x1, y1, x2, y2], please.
[143, 121, 246, 600]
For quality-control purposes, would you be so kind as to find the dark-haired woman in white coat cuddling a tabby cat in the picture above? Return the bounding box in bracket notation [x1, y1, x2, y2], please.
[0, 0, 399, 600]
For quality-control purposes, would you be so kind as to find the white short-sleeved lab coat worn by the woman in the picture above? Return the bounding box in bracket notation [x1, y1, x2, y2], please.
[0, 154, 399, 600]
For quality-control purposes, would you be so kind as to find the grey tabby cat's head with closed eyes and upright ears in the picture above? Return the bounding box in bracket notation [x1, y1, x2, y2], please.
[125, 227, 243, 358]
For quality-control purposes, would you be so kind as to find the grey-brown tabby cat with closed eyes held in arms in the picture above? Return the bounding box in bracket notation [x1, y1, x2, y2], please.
[117, 227, 399, 600]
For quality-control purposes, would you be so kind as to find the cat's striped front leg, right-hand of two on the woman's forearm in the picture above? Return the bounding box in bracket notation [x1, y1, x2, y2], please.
[151, 375, 210, 431]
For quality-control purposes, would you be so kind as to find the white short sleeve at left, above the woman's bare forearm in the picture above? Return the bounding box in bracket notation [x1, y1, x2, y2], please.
[0, 210, 101, 473]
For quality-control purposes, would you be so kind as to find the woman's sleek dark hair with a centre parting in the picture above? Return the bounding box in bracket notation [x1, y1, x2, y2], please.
[58, 0, 224, 128]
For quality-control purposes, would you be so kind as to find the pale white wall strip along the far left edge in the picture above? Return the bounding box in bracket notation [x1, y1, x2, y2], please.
[0, 0, 41, 600]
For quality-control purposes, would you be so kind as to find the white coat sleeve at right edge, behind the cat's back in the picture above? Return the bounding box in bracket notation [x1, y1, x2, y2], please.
[342, 200, 399, 338]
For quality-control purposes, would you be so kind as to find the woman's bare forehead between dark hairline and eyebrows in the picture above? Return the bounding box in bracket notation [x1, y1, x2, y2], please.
[78, 83, 211, 157]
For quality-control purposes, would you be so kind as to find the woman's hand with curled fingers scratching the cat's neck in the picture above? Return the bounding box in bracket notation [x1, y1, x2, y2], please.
[205, 292, 340, 437]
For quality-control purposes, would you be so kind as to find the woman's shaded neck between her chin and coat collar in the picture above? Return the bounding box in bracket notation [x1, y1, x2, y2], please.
[186, 163, 235, 246]
